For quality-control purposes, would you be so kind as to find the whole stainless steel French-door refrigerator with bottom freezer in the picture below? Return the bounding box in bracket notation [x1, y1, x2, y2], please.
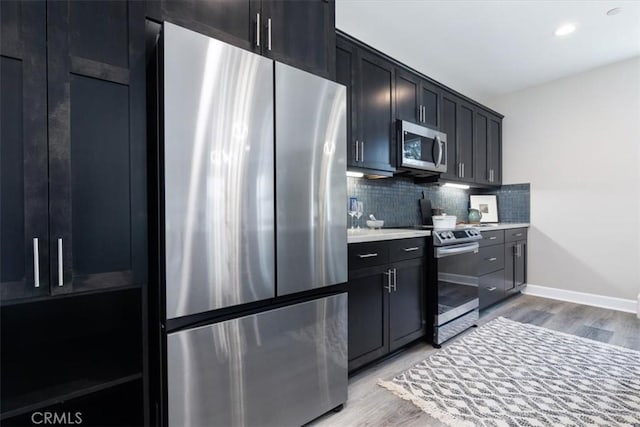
[160, 23, 347, 426]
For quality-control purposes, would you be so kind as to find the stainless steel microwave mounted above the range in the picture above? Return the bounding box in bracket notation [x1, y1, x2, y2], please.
[397, 120, 448, 175]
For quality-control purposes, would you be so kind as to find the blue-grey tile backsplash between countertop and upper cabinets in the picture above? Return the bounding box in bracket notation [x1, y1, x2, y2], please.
[345, 177, 529, 228]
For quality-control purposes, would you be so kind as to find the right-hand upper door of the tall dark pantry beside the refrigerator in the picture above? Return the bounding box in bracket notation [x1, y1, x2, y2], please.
[47, 1, 146, 294]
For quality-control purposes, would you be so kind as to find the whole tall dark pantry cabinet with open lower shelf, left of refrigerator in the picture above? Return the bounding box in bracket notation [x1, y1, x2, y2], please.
[0, 1, 147, 425]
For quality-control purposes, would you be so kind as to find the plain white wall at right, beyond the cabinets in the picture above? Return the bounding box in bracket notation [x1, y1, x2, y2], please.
[487, 57, 640, 300]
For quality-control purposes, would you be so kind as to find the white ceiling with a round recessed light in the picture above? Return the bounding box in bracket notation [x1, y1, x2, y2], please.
[336, 0, 640, 101]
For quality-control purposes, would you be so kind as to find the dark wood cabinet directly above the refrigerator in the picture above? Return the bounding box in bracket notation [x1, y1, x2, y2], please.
[147, 0, 335, 79]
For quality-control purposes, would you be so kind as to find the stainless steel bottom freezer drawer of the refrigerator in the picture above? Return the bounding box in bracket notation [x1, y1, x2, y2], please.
[167, 293, 347, 427]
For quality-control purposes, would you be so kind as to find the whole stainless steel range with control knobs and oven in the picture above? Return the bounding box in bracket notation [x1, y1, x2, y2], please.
[432, 228, 482, 347]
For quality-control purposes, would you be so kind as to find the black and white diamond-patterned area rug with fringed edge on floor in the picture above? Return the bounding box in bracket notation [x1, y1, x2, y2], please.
[378, 318, 640, 427]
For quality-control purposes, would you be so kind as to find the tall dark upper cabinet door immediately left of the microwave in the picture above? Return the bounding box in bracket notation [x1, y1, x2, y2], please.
[352, 49, 395, 171]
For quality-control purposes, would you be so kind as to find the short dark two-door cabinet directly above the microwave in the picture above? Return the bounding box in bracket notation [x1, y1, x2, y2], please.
[395, 68, 441, 129]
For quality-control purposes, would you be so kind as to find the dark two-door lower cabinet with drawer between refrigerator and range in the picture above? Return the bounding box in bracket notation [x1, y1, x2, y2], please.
[347, 238, 426, 371]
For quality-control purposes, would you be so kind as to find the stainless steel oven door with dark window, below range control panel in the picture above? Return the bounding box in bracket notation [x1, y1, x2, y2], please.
[434, 242, 479, 326]
